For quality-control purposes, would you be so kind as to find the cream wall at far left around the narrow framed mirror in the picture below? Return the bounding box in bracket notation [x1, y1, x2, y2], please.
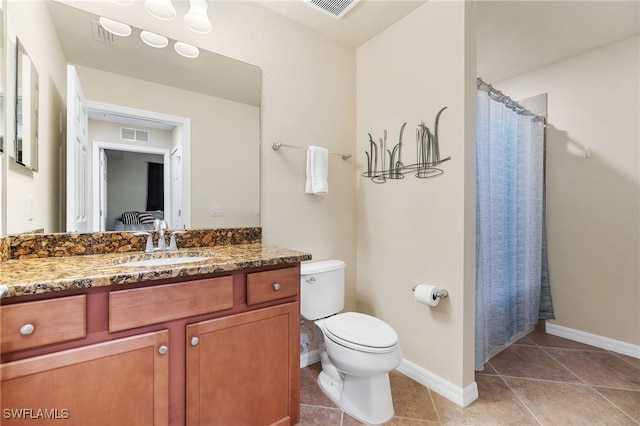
[3, 1, 66, 234]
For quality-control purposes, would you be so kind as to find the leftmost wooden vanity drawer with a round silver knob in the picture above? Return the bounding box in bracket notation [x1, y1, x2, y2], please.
[0, 295, 87, 353]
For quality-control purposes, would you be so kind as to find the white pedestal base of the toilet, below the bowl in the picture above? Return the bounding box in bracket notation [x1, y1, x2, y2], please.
[318, 371, 394, 425]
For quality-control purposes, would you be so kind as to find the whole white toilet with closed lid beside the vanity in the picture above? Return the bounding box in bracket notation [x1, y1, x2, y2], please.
[300, 260, 402, 425]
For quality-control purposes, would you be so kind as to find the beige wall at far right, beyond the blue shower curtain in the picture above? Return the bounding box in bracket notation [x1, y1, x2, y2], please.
[495, 37, 640, 345]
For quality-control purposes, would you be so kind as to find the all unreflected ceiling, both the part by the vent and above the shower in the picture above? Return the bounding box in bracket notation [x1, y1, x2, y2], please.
[257, 0, 640, 83]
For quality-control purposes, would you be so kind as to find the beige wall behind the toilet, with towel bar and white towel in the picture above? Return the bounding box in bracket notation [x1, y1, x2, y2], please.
[204, 2, 356, 309]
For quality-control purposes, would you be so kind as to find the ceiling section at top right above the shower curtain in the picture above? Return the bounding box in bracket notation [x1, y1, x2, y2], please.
[476, 0, 640, 83]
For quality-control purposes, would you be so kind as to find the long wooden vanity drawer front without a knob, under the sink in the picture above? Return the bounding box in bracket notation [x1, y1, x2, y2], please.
[109, 276, 233, 332]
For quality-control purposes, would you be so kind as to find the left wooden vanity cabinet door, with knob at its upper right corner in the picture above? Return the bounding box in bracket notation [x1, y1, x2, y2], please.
[0, 330, 169, 426]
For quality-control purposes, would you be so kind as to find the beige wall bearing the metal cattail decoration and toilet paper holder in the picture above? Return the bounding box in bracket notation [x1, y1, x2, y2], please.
[357, 2, 475, 388]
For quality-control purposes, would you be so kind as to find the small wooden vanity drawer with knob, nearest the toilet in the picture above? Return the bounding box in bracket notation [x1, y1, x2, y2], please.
[247, 268, 300, 305]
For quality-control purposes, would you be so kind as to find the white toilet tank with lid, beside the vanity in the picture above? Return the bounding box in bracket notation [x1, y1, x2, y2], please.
[300, 260, 347, 320]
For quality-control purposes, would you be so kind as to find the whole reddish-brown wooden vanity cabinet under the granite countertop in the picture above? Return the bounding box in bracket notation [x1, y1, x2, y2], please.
[0, 265, 300, 426]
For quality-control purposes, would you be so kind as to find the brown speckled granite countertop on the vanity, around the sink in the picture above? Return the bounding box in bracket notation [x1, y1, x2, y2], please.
[0, 243, 311, 298]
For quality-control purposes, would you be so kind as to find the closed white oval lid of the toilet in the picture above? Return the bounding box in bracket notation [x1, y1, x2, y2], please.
[324, 312, 398, 348]
